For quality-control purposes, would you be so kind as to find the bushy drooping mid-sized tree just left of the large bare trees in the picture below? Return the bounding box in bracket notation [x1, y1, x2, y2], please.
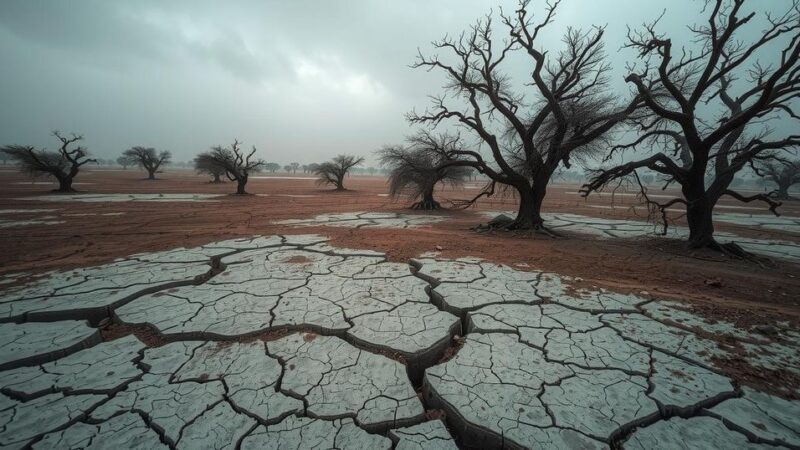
[380, 131, 471, 210]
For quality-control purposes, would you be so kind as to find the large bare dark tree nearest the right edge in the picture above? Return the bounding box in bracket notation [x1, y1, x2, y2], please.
[582, 0, 800, 256]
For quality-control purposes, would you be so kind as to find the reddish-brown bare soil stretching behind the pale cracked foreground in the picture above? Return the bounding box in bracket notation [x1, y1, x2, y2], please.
[0, 168, 800, 325]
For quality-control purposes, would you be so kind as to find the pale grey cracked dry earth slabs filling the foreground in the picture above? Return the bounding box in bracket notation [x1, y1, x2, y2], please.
[0, 234, 800, 449]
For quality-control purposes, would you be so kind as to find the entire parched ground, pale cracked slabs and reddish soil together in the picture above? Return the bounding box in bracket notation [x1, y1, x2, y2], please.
[0, 168, 800, 448]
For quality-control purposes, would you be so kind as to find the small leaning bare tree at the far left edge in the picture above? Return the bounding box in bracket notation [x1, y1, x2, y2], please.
[0, 131, 97, 192]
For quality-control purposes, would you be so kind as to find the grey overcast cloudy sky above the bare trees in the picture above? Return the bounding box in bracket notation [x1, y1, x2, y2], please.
[0, 0, 785, 163]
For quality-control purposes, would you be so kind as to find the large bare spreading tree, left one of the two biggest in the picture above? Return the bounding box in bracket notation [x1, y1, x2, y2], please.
[408, 0, 641, 230]
